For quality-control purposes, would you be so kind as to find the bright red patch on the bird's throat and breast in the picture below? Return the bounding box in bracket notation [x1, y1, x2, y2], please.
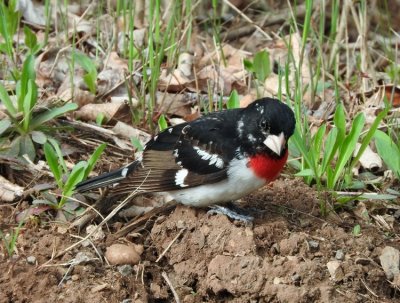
[249, 150, 288, 182]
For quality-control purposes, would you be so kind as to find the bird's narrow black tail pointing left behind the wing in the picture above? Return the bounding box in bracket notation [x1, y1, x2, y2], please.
[75, 161, 140, 193]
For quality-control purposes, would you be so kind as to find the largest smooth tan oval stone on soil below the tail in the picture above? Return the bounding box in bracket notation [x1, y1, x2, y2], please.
[105, 244, 143, 265]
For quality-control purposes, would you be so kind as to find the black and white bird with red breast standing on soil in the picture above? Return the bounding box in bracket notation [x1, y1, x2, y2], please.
[77, 98, 295, 207]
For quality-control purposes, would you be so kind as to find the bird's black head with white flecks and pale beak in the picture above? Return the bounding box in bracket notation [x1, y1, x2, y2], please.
[237, 98, 296, 157]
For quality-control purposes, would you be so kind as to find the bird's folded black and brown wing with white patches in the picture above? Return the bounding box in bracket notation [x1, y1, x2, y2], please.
[107, 110, 244, 194]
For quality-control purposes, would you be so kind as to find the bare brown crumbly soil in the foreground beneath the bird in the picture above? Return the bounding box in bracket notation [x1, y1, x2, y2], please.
[0, 180, 400, 302]
